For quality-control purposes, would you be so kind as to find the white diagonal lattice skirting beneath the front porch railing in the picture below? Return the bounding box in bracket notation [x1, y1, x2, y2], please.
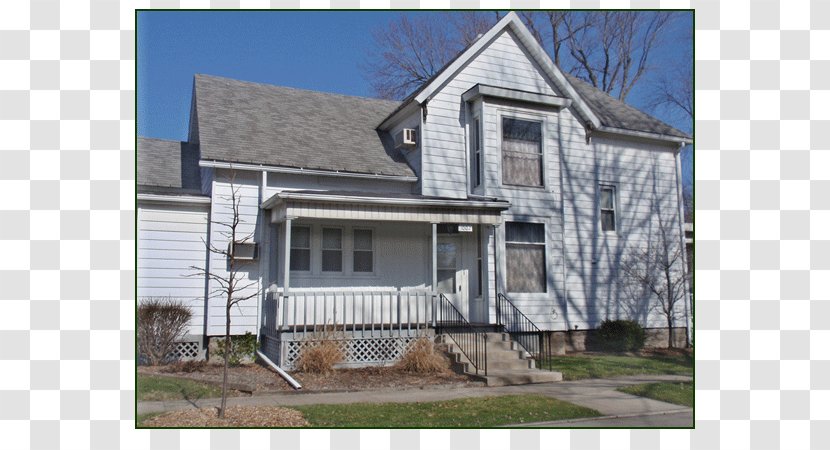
[280, 335, 426, 370]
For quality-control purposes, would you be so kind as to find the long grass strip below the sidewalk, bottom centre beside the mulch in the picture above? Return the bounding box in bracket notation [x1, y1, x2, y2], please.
[294, 395, 600, 428]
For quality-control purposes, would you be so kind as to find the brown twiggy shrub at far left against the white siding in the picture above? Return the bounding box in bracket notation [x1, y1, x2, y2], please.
[138, 297, 193, 366]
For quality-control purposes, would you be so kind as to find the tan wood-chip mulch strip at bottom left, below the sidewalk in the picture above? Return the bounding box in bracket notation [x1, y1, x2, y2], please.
[141, 406, 308, 428]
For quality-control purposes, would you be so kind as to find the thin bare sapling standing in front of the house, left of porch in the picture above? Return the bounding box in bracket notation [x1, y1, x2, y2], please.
[191, 169, 259, 419]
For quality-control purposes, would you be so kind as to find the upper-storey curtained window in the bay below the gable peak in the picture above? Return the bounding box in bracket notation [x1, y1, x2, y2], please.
[501, 117, 544, 186]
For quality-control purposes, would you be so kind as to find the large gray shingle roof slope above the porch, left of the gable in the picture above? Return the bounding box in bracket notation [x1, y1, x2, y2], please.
[194, 75, 415, 176]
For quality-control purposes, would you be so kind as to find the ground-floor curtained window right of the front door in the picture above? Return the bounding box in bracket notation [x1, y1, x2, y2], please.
[505, 222, 547, 292]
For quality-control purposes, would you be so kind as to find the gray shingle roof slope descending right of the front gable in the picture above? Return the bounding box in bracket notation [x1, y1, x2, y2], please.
[565, 73, 691, 139]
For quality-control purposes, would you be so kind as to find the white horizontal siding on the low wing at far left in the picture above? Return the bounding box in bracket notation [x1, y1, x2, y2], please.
[136, 202, 208, 335]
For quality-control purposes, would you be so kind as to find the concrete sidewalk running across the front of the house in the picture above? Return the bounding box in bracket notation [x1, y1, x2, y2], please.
[138, 375, 693, 428]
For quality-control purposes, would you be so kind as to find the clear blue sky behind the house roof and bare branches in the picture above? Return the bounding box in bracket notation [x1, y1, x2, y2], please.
[137, 11, 691, 140]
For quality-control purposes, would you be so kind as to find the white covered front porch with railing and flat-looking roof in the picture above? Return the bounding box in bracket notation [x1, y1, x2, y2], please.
[260, 192, 508, 369]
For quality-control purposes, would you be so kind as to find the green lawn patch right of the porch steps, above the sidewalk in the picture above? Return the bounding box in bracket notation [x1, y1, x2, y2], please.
[544, 355, 692, 380]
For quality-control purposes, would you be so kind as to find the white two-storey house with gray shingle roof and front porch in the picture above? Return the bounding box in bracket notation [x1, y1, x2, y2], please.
[137, 13, 691, 367]
